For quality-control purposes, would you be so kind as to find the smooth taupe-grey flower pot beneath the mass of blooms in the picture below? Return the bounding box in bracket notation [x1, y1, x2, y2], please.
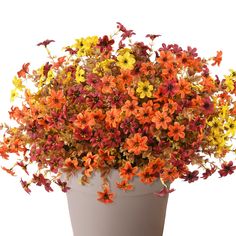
[67, 170, 168, 236]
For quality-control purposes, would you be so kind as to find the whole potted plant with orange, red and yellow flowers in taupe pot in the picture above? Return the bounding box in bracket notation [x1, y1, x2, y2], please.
[0, 23, 236, 236]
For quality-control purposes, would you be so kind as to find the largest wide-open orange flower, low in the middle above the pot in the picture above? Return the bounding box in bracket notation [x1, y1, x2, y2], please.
[125, 133, 148, 155]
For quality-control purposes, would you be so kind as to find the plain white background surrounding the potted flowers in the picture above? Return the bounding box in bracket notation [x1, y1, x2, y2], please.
[0, 0, 236, 236]
